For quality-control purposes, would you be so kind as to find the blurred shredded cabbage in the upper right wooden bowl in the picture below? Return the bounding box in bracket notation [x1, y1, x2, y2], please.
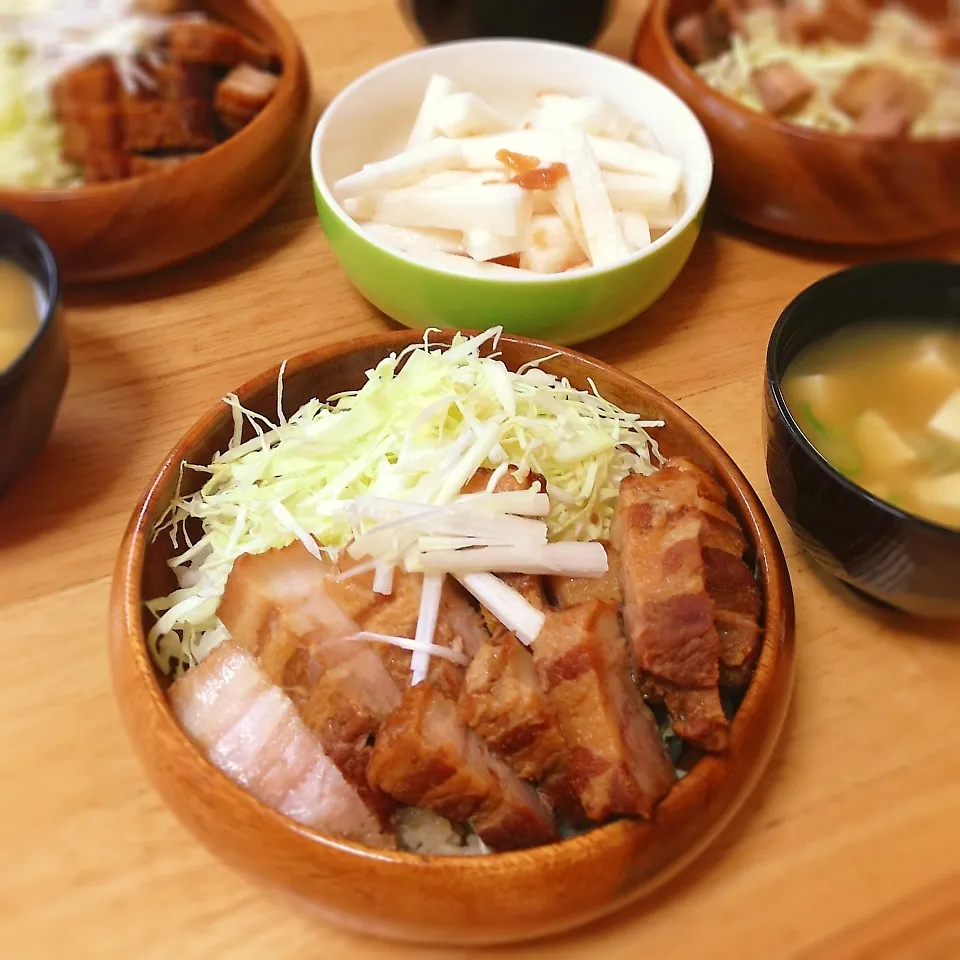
[696, 5, 960, 137]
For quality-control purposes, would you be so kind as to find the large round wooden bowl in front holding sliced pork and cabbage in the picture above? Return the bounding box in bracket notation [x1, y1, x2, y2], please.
[110, 332, 794, 945]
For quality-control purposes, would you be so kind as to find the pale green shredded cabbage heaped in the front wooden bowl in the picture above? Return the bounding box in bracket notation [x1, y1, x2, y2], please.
[147, 328, 663, 675]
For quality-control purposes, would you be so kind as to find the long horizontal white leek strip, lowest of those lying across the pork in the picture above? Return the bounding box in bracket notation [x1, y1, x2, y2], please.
[404, 541, 607, 577]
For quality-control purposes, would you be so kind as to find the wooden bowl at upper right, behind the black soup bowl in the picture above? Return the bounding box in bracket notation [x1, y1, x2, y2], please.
[633, 0, 960, 245]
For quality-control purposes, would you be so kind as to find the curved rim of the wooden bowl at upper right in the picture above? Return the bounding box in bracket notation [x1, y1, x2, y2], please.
[634, 0, 960, 151]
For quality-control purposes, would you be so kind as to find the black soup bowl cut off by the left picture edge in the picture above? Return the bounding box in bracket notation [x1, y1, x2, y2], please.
[0, 210, 69, 496]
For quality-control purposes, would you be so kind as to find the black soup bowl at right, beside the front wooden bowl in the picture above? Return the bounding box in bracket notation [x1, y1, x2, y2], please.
[764, 260, 960, 619]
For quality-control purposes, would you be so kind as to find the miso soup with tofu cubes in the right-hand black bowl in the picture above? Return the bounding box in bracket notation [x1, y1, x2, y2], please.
[782, 320, 960, 529]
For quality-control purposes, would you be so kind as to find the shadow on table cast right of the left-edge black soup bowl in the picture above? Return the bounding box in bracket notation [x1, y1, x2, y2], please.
[0, 323, 151, 548]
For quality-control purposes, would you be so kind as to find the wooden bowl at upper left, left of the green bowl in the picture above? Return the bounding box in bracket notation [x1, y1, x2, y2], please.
[0, 0, 310, 282]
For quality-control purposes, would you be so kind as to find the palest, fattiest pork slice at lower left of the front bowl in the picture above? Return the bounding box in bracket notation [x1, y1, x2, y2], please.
[169, 641, 396, 847]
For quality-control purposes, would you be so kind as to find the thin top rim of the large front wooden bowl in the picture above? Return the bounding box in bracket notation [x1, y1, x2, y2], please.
[110, 329, 794, 880]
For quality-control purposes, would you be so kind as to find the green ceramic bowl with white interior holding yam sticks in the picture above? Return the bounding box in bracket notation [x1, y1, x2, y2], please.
[310, 40, 713, 344]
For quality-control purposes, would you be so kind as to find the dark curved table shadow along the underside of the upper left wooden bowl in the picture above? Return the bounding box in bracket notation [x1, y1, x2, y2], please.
[64, 102, 325, 307]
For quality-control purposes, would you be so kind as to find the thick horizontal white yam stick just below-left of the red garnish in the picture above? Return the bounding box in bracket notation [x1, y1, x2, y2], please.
[374, 183, 533, 237]
